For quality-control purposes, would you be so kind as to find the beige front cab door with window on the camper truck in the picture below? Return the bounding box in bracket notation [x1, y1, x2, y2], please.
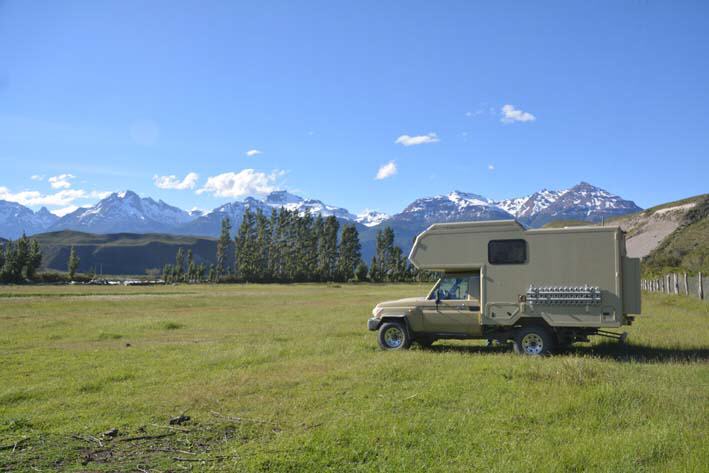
[423, 274, 482, 336]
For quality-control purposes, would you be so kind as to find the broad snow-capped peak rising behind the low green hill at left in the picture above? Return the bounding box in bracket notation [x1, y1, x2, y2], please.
[48, 191, 195, 233]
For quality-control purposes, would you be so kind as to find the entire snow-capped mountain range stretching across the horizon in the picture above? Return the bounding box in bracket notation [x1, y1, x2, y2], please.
[0, 182, 642, 240]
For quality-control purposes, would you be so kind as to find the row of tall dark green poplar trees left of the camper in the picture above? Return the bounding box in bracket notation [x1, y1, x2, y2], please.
[163, 209, 432, 282]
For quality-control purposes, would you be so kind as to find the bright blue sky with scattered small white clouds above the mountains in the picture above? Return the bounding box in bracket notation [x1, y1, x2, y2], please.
[0, 0, 709, 213]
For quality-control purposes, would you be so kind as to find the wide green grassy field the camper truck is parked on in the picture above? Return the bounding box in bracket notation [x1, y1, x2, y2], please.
[0, 285, 709, 472]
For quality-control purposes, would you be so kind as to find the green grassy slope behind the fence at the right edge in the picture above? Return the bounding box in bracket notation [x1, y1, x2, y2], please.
[643, 195, 709, 274]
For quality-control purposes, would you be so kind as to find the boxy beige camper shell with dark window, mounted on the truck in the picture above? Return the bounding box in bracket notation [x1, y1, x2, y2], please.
[409, 220, 640, 328]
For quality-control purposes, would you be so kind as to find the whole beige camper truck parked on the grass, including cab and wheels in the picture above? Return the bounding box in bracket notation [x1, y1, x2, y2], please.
[368, 220, 640, 355]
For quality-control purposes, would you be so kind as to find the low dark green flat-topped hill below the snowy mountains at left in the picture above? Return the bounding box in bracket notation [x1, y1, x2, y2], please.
[33, 231, 217, 274]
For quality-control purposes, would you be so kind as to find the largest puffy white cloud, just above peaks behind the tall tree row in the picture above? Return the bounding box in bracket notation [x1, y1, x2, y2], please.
[197, 169, 284, 197]
